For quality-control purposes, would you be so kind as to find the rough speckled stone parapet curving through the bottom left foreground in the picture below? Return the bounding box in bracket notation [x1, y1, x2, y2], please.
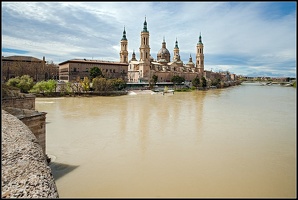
[1, 110, 59, 198]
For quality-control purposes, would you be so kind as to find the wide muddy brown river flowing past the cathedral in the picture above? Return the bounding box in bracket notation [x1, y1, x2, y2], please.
[36, 84, 296, 197]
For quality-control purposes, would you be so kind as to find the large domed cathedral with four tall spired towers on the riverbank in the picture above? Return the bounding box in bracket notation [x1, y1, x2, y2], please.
[120, 18, 204, 83]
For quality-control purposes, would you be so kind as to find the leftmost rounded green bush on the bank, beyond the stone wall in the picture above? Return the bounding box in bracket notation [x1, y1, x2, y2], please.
[6, 75, 34, 93]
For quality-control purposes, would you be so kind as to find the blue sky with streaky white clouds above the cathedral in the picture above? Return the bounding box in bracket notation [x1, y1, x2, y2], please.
[1, 1, 297, 77]
